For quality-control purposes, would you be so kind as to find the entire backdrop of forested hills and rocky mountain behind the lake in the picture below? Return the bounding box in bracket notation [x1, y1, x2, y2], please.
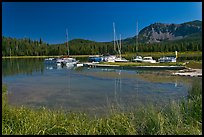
[2, 20, 202, 56]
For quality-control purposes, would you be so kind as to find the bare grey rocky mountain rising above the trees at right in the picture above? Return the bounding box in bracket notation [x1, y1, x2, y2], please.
[123, 20, 202, 44]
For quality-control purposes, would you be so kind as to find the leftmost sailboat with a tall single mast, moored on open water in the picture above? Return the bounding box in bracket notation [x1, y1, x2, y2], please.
[57, 29, 79, 68]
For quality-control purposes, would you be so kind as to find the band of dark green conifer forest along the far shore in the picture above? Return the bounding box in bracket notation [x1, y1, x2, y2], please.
[2, 36, 202, 56]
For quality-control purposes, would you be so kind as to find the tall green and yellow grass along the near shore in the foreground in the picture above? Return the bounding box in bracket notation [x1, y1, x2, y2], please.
[2, 81, 202, 135]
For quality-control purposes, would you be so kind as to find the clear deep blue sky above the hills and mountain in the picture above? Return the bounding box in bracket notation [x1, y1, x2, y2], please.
[2, 2, 202, 44]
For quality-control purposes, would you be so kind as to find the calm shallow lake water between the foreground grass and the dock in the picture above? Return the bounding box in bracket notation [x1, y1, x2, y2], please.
[2, 59, 201, 115]
